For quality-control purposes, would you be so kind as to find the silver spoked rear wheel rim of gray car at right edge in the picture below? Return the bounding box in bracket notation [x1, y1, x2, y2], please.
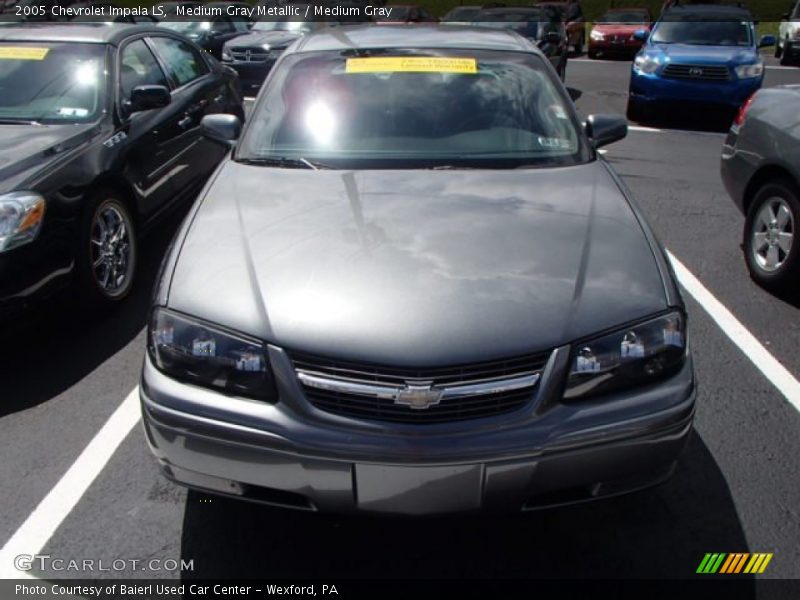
[750, 196, 794, 273]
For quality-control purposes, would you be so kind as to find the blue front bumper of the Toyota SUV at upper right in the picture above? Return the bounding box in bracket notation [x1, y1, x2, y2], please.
[630, 69, 763, 108]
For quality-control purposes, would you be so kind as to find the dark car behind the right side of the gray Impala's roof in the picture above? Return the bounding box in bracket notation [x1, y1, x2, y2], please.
[473, 6, 569, 81]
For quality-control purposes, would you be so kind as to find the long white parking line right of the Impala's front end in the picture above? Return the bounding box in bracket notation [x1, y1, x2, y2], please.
[668, 252, 800, 412]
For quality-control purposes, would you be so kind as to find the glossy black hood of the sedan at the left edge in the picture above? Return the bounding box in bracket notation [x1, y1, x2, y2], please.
[0, 124, 94, 191]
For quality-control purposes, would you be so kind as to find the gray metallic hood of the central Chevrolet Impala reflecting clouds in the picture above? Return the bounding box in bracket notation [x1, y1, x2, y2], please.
[168, 162, 666, 366]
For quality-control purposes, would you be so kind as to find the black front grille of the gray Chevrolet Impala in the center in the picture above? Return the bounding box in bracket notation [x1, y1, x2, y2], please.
[292, 353, 549, 424]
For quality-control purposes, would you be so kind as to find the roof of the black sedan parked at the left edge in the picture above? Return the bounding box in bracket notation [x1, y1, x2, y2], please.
[0, 23, 165, 46]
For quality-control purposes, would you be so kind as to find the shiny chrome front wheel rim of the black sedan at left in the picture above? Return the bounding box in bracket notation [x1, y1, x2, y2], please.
[89, 201, 134, 298]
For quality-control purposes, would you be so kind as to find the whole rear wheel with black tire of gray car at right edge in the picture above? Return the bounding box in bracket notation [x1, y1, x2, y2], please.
[743, 178, 800, 292]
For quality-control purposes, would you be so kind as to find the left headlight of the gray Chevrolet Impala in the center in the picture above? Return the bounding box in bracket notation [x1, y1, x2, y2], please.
[148, 308, 277, 402]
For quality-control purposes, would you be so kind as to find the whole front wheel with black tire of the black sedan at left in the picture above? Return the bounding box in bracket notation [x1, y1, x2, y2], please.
[76, 189, 138, 307]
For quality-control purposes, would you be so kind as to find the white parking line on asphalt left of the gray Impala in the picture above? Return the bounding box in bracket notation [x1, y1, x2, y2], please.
[0, 387, 139, 579]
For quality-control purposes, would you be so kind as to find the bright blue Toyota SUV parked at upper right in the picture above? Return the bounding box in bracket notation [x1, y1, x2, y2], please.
[628, 5, 775, 121]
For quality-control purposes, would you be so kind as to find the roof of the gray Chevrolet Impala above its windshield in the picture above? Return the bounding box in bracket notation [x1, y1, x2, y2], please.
[293, 24, 537, 53]
